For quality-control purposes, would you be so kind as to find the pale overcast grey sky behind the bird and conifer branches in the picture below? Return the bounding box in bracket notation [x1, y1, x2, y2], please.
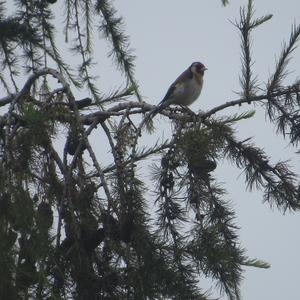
[4, 0, 300, 300]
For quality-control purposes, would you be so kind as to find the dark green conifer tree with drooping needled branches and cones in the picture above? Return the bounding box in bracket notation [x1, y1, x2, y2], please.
[0, 0, 300, 300]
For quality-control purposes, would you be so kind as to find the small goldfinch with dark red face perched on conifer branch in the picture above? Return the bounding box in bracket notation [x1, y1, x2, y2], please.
[158, 62, 207, 108]
